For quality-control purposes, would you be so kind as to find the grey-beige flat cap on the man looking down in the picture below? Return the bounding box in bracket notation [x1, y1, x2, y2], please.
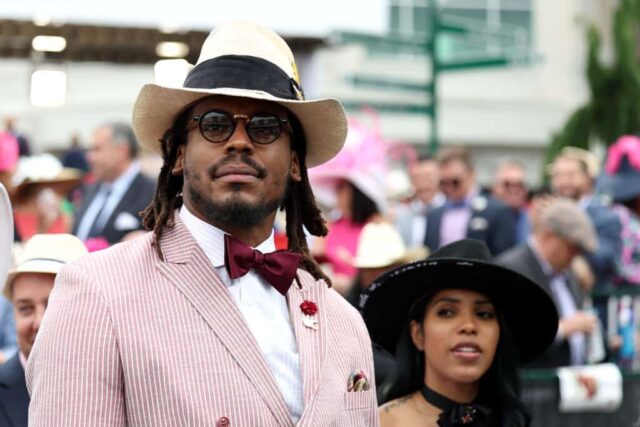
[539, 199, 598, 253]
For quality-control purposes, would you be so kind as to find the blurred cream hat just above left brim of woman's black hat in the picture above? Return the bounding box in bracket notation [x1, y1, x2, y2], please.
[353, 222, 427, 268]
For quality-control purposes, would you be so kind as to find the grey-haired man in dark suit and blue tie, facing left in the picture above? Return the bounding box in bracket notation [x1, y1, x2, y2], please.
[73, 123, 155, 244]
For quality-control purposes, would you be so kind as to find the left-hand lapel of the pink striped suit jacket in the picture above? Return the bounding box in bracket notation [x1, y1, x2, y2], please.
[157, 219, 291, 426]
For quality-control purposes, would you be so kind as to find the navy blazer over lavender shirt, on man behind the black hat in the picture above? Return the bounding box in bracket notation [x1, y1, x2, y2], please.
[424, 195, 517, 256]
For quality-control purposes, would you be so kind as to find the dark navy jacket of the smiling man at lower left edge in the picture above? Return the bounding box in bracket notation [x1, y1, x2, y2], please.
[0, 353, 30, 427]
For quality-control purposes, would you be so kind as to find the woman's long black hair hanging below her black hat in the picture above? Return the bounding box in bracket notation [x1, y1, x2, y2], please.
[379, 292, 531, 427]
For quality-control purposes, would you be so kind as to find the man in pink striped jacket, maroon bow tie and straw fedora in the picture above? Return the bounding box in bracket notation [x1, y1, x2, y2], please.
[27, 23, 378, 426]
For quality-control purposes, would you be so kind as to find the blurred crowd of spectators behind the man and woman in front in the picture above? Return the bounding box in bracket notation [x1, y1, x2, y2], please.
[0, 109, 640, 402]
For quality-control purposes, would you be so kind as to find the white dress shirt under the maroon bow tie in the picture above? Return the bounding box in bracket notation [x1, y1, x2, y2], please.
[180, 206, 304, 423]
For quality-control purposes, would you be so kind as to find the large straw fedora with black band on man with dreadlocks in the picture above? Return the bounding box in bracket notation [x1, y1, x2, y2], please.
[132, 22, 347, 167]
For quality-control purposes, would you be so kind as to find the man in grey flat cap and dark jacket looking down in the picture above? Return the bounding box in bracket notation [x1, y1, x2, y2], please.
[496, 199, 597, 368]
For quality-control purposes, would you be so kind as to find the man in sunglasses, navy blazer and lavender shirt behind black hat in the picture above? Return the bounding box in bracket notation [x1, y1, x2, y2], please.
[424, 148, 516, 255]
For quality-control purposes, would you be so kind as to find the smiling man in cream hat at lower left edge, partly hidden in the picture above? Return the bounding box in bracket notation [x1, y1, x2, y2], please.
[0, 234, 87, 427]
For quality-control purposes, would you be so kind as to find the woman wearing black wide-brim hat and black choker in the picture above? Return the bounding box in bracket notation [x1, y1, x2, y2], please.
[360, 239, 558, 427]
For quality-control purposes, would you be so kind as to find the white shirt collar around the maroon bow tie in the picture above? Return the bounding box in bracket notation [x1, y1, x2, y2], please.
[180, 205, 276, 268]
